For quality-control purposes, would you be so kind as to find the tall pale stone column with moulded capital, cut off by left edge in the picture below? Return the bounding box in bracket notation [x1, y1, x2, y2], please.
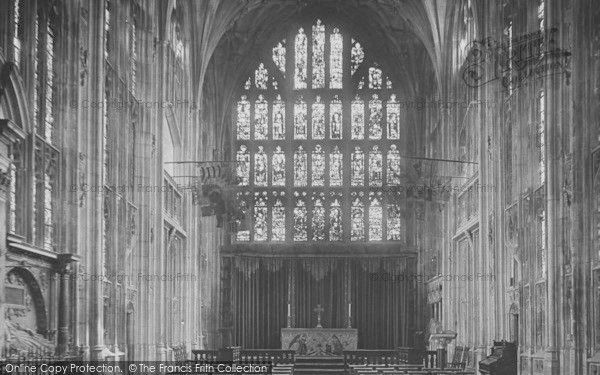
[0, 118, 25, 353]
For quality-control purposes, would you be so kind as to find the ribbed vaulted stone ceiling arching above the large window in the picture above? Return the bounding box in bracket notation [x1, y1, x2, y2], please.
[180, 0, 476, 101]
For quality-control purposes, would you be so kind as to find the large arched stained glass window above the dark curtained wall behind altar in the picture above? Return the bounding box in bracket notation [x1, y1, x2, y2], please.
[233, 20, 406, 243]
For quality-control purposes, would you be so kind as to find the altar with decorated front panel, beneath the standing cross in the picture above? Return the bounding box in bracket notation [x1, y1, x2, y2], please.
[281, 328, 358, 356]
